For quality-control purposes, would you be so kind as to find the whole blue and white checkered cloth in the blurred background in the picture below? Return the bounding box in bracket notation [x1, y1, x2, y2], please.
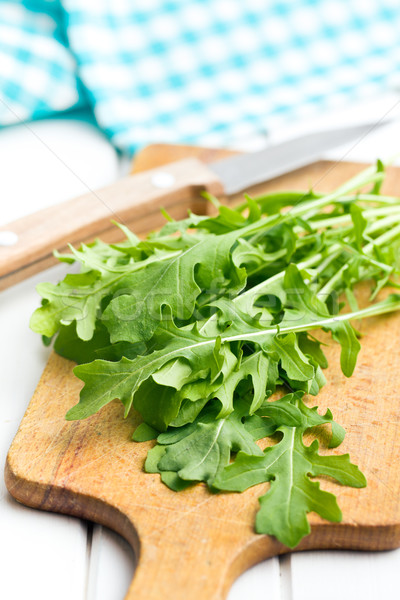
[0, 0, 400, 153]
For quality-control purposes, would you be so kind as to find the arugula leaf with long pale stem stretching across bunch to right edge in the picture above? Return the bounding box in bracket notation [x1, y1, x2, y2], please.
[67, 295, 400, 429]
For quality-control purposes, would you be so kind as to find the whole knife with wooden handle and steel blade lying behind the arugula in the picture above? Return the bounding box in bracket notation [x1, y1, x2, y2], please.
[0, 120, 387, 289]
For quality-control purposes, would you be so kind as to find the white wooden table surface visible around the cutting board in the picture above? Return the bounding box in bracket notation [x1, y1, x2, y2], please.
[0, 107, 400, 600]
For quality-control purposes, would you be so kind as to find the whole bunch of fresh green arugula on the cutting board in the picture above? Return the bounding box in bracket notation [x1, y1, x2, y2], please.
[31, 162, 400, 547]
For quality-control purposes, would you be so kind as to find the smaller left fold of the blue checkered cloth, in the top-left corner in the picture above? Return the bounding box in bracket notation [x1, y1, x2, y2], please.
[0, 0, 86, 125]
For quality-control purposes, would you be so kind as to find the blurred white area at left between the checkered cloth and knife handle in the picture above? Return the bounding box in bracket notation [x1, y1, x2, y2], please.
[0, 113, 119, 224]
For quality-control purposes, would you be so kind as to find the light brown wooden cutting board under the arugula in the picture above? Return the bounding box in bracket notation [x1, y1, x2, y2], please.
[5, 146, 400, 600]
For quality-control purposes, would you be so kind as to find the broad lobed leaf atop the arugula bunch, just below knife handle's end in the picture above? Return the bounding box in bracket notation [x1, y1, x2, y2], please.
[103, 232, 245, 342]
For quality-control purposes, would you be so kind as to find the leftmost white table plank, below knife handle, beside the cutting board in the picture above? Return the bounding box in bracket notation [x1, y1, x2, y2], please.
[0, 269, 87, 600]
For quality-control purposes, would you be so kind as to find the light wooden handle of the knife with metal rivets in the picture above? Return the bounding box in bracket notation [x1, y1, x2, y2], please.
[0, 158, 223, 289]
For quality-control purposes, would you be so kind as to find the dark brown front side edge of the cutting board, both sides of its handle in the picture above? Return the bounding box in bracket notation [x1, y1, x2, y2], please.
[4, 446, 400, 552]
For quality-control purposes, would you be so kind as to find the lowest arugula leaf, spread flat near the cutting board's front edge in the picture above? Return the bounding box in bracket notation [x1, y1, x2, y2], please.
[213, 398, 366, 548]
